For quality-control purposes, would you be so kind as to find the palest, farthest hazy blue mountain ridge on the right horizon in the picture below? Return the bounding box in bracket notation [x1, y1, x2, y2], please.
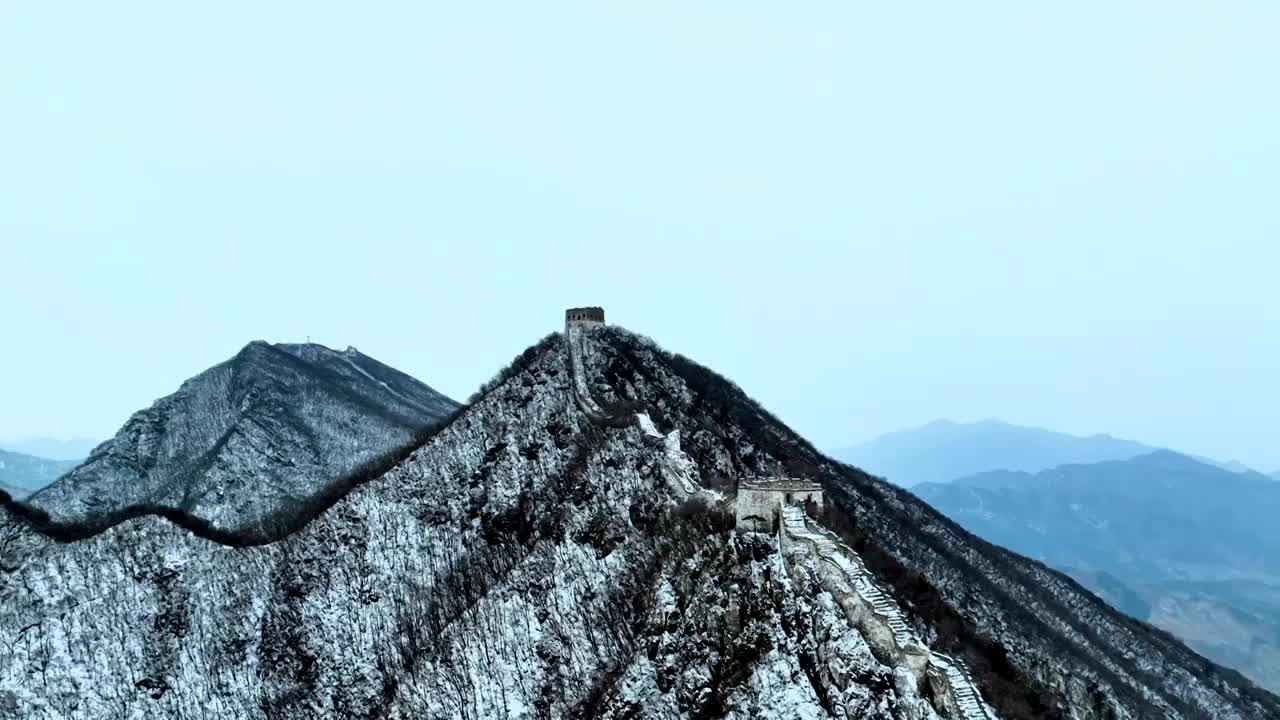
[833, 420, 1156, 487]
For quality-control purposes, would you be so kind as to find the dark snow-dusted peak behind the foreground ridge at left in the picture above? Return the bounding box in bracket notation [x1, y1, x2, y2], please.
[27, 342, 457, 534]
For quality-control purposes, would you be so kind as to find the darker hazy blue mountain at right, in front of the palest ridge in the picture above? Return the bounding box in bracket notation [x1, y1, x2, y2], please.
[913, 451, 1280, 691]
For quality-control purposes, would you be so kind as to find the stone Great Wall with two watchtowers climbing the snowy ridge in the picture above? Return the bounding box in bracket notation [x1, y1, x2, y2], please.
[564, 307, 998, 720]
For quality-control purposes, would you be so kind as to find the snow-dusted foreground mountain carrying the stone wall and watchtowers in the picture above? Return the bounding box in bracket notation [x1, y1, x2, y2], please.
[0, 325, 1280, 720]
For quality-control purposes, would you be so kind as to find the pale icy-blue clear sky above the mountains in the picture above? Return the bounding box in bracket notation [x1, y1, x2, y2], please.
[0, 0, 1280, 466]
